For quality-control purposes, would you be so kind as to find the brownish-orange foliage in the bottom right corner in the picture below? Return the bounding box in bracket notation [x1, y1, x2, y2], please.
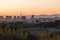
[38, 32, 60, 40]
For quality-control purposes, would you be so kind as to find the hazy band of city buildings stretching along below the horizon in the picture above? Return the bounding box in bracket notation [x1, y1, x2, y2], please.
[0, 15, 60, 23]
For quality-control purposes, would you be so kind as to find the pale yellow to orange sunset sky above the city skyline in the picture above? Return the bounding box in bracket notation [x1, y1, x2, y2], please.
[0, 0, 60, 15]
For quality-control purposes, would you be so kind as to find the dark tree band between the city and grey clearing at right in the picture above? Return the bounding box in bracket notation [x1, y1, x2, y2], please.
[23, 20, 60, 28]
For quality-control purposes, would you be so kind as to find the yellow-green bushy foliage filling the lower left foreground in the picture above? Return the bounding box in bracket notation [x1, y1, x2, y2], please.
[0, 22, 38, 40]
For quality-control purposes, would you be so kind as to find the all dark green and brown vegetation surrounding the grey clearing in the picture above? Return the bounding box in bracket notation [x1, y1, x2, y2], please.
[0, 20, 60, 40]
